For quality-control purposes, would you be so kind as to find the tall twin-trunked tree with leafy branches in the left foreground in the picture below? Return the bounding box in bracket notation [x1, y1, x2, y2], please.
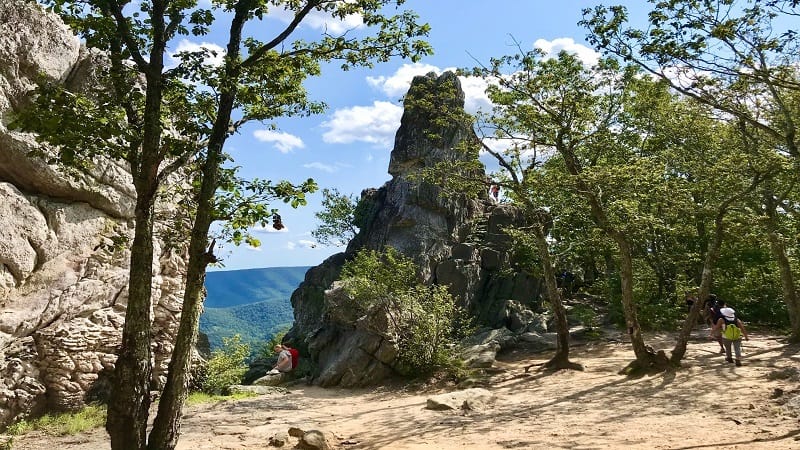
[18, 0, 430, 449]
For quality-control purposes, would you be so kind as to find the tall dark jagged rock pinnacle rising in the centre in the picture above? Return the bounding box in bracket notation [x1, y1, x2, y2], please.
[287, 73, 541, 386]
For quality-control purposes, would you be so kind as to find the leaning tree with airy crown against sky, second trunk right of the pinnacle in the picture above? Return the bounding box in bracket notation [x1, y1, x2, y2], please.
[468, 50, 676, 368]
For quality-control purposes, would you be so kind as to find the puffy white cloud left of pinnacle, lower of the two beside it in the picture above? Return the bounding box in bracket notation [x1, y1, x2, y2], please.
[322, 101, 403, 147]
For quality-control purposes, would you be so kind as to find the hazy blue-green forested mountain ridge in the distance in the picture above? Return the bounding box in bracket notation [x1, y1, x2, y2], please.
[200, 266, 309, 351]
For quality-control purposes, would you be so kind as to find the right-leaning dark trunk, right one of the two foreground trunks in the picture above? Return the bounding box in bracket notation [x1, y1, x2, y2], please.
[148, 1, 250, 450]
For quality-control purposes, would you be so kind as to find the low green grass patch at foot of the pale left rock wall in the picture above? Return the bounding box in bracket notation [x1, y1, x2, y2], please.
[6, 406, 106, 436]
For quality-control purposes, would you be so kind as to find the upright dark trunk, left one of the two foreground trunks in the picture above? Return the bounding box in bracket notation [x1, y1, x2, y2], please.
[106, 6, 166, 442]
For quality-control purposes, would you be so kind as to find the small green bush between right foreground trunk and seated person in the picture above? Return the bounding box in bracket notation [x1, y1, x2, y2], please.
[201, 334, 250, 394]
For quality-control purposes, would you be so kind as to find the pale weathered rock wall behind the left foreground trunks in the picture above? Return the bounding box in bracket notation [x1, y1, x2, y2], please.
[0, 0, 185, 428]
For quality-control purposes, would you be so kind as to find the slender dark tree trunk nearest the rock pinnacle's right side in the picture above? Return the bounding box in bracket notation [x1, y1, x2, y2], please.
[534, 217, 583, 370]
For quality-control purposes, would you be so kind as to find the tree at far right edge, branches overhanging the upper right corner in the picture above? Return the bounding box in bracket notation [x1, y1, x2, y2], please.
[581, 0, 800, 341]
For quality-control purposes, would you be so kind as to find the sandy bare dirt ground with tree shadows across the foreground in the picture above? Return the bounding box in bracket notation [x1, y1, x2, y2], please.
[14, 330, 800, 450]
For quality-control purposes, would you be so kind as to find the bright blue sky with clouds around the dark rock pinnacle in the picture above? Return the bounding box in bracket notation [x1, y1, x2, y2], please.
[195, 0, 647, 270]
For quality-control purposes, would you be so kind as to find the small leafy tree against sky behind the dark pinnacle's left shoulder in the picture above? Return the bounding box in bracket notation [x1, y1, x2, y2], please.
[311, 189, 358, 247]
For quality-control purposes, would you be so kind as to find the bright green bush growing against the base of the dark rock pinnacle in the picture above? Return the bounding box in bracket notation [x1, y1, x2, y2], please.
[341, 247, 468, 376]
